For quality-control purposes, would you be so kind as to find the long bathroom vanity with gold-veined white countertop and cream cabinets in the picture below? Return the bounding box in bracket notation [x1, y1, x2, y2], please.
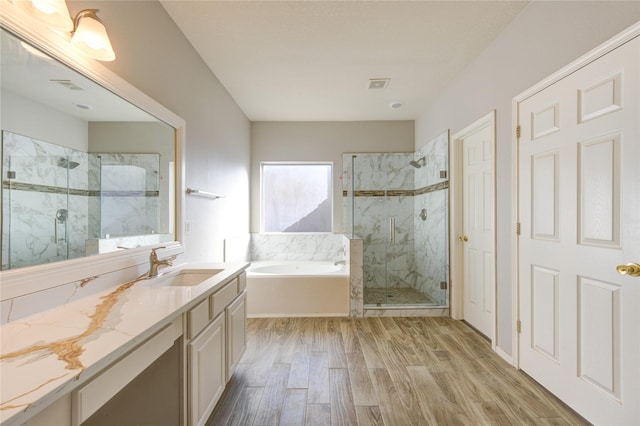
[0, 251, 248, 426]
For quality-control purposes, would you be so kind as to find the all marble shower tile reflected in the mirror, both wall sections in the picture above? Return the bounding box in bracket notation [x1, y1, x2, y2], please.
[2, 131, 159, 269]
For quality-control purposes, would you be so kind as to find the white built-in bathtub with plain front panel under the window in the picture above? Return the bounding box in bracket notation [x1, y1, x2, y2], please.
[247, 261, 349, 318]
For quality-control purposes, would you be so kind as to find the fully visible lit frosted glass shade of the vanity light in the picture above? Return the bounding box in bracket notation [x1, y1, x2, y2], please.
[71, 9, 116, 61]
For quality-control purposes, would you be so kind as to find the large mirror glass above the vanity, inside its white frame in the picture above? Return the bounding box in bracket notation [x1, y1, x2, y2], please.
[0, 29, 176, 270]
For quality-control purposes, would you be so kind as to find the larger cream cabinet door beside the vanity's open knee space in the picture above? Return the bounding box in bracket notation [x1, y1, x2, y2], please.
[187, 314, 226, 426]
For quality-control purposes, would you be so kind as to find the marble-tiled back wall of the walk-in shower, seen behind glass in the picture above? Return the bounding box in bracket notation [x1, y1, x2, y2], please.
[351, 153, 428, 307]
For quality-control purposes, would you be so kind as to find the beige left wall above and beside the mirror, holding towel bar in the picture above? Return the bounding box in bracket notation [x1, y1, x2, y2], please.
[75, 1, 250, 261]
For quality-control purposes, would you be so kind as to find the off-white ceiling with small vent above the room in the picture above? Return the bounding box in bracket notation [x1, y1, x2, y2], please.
[161, 0, 526, 121]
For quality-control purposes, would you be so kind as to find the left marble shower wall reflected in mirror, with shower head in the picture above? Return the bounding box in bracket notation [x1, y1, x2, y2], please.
[2, 131, 89, 269]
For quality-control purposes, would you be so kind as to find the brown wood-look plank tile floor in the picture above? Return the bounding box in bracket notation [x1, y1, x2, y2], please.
[207, 317, 587, 426]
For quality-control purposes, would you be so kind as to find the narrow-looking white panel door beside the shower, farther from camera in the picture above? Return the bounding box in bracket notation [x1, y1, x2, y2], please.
[460, 119, 495, 340]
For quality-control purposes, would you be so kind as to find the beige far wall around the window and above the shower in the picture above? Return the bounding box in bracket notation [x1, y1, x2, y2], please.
[251, 121, 414, 233]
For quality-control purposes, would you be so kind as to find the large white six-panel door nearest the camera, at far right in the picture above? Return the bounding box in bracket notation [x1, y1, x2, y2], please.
[518, 38, 640, 425]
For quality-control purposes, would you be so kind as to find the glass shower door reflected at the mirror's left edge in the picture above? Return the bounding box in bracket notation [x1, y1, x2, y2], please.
[2, 156, 70, 269]
